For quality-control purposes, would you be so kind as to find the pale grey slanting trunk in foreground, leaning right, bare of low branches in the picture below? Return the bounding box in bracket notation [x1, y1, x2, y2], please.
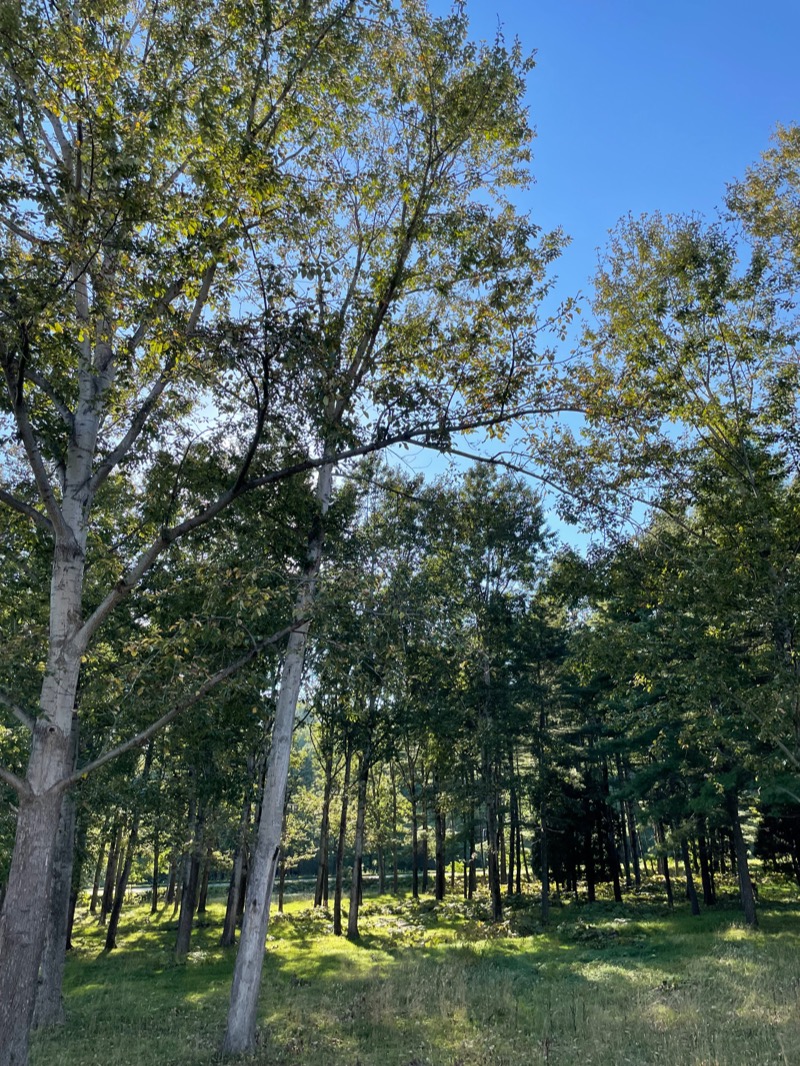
[224, 463, 333, 1054]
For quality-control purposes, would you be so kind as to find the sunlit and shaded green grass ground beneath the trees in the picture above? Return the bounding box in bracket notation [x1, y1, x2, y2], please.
[32, 882, 800, 1066]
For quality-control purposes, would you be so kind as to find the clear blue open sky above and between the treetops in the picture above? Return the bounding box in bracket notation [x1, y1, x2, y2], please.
[430, 0, 800, 311]
